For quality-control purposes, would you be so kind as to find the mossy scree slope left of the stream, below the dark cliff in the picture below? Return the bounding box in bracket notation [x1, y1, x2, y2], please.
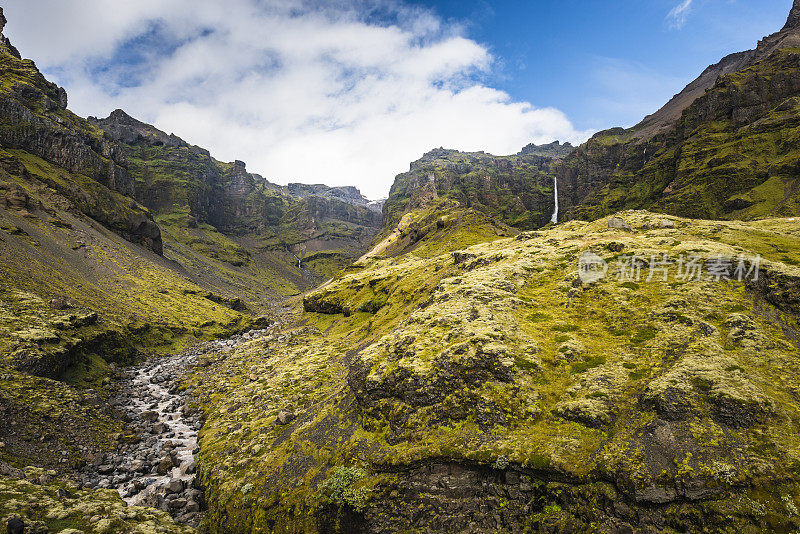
[0, 154, 262, 470]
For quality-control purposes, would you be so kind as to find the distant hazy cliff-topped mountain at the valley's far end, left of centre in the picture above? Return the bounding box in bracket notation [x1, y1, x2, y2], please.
[89, 110, 381, 284]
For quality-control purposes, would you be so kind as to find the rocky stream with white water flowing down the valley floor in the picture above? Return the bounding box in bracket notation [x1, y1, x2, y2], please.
[82, 330, 267, 526]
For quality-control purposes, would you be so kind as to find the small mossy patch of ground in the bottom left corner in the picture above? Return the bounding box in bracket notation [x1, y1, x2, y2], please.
[0, 474, 195, 534]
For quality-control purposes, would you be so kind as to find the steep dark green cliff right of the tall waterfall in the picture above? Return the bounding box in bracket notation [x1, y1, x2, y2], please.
[554, 4, 800, 220]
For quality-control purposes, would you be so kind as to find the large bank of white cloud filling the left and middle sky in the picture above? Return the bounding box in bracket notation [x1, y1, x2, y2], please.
[4, 0, 587, 197]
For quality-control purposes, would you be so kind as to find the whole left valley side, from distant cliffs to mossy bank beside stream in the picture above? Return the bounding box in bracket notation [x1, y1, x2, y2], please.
[0, 9, 381, 532]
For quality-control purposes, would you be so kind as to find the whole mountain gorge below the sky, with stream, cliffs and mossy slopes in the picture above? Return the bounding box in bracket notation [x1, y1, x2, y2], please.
[0, 0, 800, 534]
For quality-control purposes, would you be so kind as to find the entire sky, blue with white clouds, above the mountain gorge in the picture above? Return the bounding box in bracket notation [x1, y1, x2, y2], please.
[1, 0, 792, 198]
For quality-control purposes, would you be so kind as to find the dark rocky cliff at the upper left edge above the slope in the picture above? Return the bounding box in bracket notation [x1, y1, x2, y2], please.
[0, 11, 162, 253]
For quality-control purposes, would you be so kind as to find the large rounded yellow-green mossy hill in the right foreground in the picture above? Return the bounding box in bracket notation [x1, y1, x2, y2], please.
[192, 212, 800, 532]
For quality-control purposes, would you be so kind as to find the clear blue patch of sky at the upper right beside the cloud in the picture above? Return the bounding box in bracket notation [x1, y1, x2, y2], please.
[416, 0, 792, 130]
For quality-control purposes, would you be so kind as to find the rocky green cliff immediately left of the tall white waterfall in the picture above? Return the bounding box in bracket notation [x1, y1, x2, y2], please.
[384, 149, 554, 234]
